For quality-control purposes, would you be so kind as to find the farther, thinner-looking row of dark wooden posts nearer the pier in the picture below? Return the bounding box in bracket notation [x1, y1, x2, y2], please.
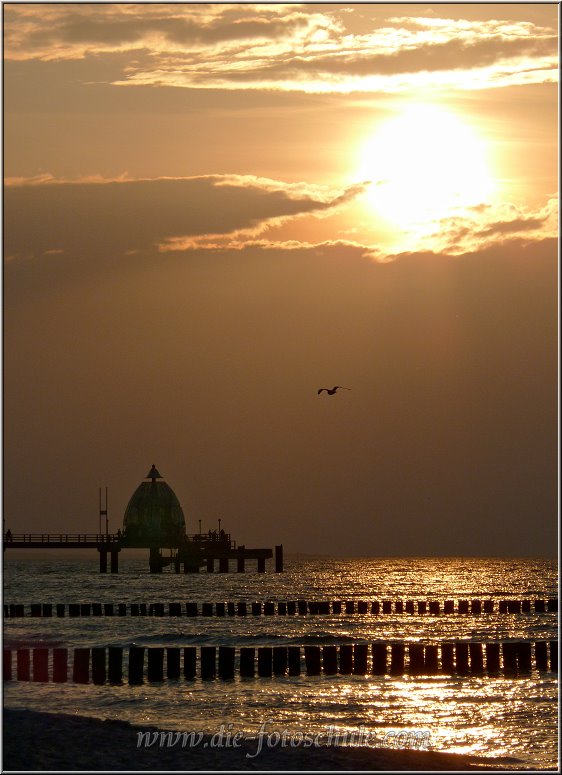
[4, 598, 558, 618]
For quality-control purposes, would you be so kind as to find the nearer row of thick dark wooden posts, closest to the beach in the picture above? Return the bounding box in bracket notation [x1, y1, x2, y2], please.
[3, 641, 558, 684]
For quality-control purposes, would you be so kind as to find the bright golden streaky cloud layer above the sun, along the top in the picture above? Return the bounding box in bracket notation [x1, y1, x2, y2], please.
[5, 4, 558, 93]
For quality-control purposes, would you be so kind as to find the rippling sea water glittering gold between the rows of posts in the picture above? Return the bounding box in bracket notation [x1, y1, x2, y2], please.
[3, 551, 558, 769]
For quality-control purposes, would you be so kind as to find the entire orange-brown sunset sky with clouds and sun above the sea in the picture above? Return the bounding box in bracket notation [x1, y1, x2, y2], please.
[3, 2, 558, 557]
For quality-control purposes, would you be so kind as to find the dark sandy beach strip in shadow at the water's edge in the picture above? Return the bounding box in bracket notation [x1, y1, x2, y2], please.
[2, 709, 526, 771]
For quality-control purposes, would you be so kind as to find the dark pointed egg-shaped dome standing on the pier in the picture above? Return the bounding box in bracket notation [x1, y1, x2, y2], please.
[123, 465, 185, 547]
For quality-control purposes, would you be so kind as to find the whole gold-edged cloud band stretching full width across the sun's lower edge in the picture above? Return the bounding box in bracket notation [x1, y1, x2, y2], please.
[4, 175, 558, 263]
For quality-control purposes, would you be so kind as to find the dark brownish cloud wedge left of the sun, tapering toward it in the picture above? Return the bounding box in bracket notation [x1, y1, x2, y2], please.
[4, 175, 363, 260]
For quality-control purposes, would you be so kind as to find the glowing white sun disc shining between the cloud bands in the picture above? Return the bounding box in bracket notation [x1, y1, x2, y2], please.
[357, 104, 494, 231]
